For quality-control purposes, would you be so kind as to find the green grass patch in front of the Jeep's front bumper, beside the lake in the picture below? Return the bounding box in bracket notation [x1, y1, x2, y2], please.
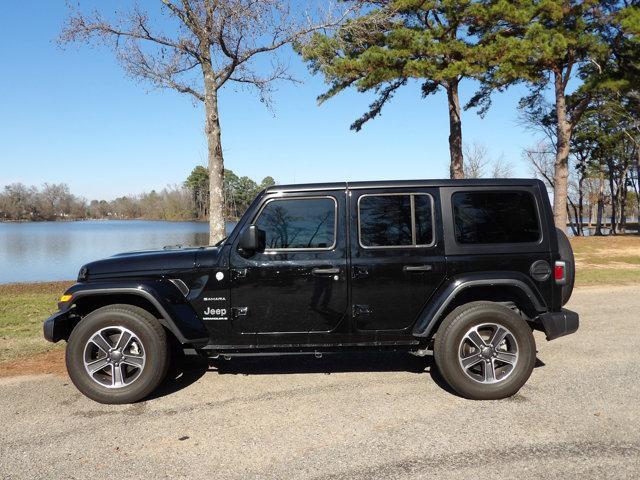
[0, 282, 71, 364]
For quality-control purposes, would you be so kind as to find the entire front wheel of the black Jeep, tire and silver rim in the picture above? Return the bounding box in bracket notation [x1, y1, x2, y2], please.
[66, 304, 170, 404]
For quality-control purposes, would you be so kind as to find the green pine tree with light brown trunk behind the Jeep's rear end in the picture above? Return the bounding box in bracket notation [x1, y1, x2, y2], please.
[470, 0, 619, 230]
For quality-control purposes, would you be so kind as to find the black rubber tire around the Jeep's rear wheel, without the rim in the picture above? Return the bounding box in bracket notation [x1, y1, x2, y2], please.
[434, 302, 536, 400]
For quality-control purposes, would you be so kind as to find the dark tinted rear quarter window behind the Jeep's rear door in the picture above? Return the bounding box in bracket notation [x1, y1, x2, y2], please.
[451, 190, 540, 244]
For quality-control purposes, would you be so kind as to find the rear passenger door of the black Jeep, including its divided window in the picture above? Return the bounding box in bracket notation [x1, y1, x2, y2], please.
[350, 188, 445, 340]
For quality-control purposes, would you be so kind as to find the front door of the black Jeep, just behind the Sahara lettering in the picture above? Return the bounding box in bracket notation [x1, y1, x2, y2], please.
[230, 190, 348, 345]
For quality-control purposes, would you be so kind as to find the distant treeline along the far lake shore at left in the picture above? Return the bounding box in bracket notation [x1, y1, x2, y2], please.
[0, 166, 275, 221]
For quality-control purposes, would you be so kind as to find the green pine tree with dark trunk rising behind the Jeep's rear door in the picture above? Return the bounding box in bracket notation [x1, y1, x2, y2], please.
[297, 0, 485, 178]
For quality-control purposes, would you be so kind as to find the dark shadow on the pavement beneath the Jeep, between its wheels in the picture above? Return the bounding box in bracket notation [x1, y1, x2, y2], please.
[145, 352, 545, 400]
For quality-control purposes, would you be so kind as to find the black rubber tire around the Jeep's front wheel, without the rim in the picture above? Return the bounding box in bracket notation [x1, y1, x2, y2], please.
[66, 307, 167, 403]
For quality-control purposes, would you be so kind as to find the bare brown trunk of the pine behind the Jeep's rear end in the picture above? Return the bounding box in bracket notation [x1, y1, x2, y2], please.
[553, 71, 571, 232]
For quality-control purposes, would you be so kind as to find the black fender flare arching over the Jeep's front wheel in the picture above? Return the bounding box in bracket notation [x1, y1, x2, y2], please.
[61, 280, 209, 344]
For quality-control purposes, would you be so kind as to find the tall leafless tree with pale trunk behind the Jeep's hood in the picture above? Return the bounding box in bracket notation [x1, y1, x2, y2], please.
[60, 0, 346, 243]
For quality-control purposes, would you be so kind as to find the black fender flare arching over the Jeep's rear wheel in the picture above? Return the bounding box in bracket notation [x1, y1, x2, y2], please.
[413, 271, 548, 337]
